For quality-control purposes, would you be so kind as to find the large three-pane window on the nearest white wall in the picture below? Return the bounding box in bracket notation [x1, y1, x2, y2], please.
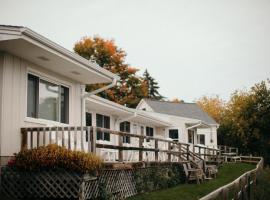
[27, 74, 69, 124]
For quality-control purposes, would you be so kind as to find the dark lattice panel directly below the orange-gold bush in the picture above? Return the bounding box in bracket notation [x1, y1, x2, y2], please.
[1, 168, 82, 199]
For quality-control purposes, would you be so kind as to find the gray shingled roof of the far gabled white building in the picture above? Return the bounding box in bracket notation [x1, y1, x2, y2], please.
[144, 99, 217, 124]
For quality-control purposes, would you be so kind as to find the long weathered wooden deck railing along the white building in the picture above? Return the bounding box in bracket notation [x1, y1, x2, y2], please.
[21, 126, 198, 162]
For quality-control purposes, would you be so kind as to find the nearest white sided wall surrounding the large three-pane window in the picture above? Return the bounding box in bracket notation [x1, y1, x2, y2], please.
[0, 54, 81, 156]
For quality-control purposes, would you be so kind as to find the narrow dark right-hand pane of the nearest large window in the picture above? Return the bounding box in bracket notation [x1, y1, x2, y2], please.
[61, 86, 69, 124]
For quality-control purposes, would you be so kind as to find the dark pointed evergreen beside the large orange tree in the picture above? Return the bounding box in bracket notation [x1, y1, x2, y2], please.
[143, 70, 164, 100]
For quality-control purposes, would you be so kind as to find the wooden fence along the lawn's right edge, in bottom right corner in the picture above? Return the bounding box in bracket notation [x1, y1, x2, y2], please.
[200, 156, 263, 200]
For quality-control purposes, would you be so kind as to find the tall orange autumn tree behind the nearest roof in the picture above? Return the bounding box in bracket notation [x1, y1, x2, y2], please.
[74, 36, 147, 107]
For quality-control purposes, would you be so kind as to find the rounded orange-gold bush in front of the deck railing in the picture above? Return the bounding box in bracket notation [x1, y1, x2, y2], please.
[10, 144, 102, 173]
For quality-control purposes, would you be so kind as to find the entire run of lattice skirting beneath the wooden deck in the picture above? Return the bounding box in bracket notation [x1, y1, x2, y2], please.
[1, 166, 184, 200]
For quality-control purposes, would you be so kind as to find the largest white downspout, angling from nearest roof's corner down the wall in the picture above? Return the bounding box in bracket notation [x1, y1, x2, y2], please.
[81, 78, 118, 126]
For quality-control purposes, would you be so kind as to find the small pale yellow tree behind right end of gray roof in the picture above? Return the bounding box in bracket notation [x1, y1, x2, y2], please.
[197, 95, 225, 123]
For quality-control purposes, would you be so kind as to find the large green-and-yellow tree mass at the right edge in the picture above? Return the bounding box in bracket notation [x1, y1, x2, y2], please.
[218, 80, 270, 164]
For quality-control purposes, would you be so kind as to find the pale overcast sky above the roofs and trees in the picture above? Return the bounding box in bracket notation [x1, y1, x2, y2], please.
[0, 0, 270, 102]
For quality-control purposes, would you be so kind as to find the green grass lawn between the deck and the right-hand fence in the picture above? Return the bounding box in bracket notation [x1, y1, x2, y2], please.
[128, 163, 255, 200]
